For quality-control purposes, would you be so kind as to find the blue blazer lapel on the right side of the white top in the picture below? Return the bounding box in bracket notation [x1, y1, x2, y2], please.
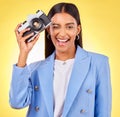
[63, 47, 90, 117]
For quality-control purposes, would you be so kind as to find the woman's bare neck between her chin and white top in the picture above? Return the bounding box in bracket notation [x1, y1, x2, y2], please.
[55, 49, 76, 61]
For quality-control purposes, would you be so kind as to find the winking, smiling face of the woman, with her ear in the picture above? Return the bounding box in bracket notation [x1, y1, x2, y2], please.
[49, 13, 80, 52]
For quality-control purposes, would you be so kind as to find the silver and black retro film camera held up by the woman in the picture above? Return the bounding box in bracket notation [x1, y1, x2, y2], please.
[18, 10, 51, 42]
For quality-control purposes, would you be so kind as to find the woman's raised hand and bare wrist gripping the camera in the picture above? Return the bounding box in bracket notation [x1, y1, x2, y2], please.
[15, 24, 39, 67]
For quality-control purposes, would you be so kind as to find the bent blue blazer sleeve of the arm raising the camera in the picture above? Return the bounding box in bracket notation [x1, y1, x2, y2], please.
[9, 65, 32, 108]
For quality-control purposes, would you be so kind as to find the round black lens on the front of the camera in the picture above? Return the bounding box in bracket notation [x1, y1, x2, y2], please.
[31, 18, 43, 31]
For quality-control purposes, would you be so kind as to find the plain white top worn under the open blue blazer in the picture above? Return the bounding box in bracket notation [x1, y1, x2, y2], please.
[53, 59, 74, 117]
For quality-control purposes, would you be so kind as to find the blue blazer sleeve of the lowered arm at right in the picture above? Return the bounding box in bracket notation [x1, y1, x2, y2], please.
[95, 57, 112, 117]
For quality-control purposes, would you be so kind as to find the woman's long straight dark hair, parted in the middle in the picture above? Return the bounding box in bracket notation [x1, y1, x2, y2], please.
[45, 2, 83, 58]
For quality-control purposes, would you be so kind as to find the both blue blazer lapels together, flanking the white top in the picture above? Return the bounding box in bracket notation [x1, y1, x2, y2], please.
[38, 46, 90, 117]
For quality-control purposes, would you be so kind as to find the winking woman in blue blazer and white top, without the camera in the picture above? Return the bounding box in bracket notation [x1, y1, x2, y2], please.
[10, 3, 111, 117]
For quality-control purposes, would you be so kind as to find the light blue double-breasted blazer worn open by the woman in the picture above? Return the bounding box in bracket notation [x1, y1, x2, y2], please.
[10, 47, 111, 117]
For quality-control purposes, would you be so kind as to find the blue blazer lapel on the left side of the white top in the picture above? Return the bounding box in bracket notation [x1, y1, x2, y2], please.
[38, 54, 54, 117]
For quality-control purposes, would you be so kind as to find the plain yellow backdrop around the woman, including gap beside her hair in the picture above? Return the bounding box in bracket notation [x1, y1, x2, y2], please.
[0, 0, 120, 117]
